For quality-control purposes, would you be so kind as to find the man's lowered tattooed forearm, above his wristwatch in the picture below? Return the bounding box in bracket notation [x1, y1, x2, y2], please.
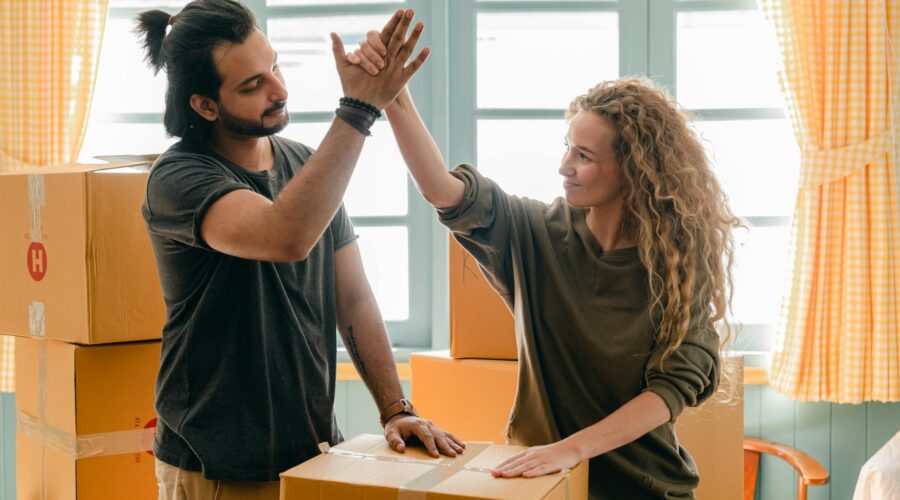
[339, 298, 403, 412]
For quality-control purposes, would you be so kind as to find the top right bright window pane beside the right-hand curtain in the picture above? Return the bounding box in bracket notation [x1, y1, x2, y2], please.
[676, 10, 783, 109]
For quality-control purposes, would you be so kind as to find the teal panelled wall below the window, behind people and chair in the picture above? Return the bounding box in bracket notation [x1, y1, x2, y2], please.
[0, 381, 900, 500]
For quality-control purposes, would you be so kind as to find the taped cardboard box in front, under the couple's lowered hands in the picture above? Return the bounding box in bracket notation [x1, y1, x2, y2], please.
[281, 434, 588, 500]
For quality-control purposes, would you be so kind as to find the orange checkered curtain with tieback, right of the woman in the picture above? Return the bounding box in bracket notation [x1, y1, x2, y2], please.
[761, 0, 900, 403]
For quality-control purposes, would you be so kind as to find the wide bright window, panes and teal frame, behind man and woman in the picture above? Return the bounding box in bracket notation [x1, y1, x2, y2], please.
[81, 0, 799, 357]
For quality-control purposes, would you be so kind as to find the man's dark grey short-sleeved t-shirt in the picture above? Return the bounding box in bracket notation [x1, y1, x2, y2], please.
[142, 136, 356, 481]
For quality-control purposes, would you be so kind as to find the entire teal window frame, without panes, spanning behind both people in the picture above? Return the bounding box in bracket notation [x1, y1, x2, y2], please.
[101, 0, 791, 360]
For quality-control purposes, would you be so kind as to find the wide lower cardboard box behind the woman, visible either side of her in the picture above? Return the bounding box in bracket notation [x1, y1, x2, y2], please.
[410, 351, 744, 500]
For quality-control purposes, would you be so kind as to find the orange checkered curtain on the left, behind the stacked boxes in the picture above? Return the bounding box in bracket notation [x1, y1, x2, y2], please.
[0, 0, 108, 391]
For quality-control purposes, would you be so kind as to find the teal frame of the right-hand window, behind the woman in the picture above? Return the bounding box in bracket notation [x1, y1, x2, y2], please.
[442, 0, 791, 351]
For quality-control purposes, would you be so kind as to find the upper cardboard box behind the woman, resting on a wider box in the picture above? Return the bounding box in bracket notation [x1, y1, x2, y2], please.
[450, 236, 518, 359]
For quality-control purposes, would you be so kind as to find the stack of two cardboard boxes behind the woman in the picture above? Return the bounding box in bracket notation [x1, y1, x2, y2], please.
[410, 237, 743, 500]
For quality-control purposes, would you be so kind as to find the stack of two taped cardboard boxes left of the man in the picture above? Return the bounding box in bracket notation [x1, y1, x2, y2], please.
[0, 163, 165, 500]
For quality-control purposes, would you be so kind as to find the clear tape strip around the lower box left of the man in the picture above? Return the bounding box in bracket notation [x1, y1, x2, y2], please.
[16, 411, 156, 460]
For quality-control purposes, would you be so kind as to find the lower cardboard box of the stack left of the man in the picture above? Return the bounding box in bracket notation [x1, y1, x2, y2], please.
[16, 338, 160, 500]
